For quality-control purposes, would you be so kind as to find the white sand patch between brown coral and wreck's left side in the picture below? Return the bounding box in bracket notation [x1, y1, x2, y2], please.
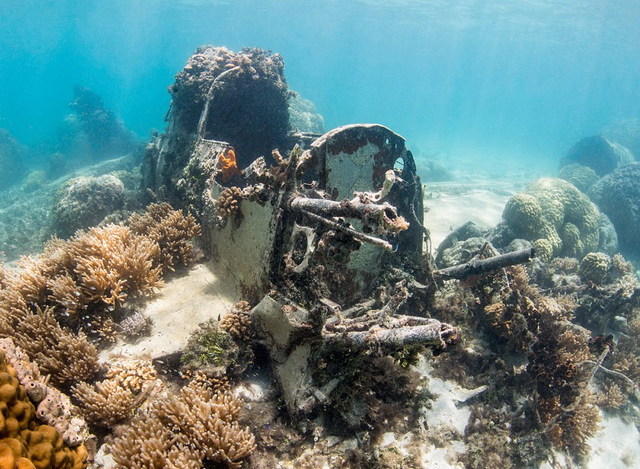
[102, 264, 238, 359]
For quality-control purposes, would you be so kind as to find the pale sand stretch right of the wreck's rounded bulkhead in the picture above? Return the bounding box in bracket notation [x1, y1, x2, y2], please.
[424, 179, 530, 249]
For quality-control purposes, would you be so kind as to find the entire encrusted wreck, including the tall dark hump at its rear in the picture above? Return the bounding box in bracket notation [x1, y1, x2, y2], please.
[143, 52, 532, 415]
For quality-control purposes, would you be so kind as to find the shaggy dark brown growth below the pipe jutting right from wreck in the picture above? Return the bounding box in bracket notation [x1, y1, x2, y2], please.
[436, 258, 607, 467]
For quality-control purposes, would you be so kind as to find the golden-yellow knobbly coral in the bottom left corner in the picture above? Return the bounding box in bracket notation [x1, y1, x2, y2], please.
[0, 351, 88, 469]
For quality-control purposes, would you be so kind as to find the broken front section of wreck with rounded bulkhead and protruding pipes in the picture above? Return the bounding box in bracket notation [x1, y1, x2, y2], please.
[144, 119, 533, 414]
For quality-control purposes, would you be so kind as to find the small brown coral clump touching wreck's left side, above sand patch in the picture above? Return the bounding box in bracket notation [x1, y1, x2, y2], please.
[128, 203, 200, 270]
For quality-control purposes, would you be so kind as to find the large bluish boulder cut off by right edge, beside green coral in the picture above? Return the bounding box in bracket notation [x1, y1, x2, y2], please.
[589, 163, 640, 257]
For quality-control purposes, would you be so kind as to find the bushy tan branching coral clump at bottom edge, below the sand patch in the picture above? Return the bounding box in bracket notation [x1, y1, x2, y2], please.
[109, 383, 255, 469]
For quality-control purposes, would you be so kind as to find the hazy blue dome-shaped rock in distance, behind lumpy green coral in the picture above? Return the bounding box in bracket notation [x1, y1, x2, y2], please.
[560, 135, 634, 176]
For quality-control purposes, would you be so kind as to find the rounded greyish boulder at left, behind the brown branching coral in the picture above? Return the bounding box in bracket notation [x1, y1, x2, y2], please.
[54, 174, 125, 237]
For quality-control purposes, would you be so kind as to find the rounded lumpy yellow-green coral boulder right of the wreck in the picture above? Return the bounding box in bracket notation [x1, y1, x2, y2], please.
[502, 178, 600, 259]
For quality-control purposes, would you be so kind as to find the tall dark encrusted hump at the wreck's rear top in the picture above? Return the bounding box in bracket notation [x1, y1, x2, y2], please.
[169, 46, 289, 167]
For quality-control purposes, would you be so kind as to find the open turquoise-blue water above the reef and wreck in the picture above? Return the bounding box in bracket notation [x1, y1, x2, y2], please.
[0, 0, 640, 172]
